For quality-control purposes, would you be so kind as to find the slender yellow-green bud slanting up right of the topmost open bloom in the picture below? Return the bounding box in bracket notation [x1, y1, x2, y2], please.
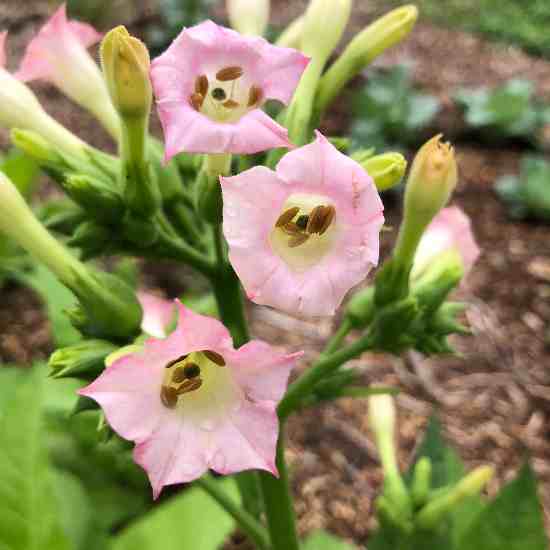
[316, 5, 418, 112]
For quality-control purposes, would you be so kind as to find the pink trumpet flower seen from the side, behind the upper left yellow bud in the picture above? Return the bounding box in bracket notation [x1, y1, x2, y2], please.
[15, 4, 118, 136]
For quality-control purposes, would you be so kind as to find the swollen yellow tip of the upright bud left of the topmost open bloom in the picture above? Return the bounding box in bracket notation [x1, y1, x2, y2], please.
[101, 25, 153, 117]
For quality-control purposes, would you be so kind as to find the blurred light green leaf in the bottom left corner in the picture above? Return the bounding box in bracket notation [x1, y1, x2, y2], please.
[0, 370, 72, 550]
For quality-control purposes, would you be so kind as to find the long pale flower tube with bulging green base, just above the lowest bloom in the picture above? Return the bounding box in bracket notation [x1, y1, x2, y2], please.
[0, 172, 141, 338]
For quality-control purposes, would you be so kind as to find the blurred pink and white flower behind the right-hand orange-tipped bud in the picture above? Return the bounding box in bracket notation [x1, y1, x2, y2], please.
[411, 206, 480, 278]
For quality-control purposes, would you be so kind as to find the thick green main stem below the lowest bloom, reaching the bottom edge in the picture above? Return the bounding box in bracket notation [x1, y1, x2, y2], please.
[260, 430, 300, 550]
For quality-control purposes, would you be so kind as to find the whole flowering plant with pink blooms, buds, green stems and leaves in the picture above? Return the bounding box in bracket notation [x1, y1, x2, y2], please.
[0, 1, 545, 548]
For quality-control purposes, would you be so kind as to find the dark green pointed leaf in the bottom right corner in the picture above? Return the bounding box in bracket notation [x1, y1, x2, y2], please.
[457, 465, 548, 550]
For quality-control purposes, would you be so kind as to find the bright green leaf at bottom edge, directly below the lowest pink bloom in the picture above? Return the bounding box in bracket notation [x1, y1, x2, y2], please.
[112, 478, 237, 550]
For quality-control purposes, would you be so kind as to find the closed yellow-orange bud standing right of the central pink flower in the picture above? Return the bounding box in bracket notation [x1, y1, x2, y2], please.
[394, 135, 458, 269]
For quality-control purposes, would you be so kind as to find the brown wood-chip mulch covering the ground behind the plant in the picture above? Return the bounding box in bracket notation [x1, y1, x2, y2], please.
[0, 1, 550, 548]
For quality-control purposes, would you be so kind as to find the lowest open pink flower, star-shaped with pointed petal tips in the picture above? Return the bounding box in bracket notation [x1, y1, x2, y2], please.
[79, 301, 301, 498]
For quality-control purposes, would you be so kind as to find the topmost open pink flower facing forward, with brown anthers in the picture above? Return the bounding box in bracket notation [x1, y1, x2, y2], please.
[151, 21, 309, 160]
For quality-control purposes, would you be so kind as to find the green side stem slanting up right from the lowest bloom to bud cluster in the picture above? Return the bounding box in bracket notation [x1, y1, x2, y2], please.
[277, 335, 372, 420]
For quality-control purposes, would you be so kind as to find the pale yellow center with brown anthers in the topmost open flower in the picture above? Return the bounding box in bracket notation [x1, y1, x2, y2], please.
[189, 65, 263, 123]
